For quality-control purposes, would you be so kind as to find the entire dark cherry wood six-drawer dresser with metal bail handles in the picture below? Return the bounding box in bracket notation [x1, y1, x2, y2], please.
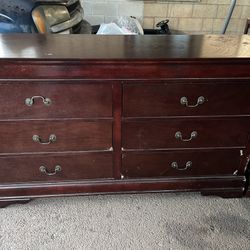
[0, 35, 250, 207]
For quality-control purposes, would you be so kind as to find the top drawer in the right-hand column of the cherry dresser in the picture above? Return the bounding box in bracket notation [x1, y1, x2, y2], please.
[123, 80, 250, 117]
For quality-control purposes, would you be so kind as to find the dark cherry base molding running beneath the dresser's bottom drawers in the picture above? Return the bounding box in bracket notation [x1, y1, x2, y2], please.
[0, 177, 245, 200]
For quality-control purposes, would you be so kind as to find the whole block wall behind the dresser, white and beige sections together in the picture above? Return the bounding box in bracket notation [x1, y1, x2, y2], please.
[81, 0, 250, 34]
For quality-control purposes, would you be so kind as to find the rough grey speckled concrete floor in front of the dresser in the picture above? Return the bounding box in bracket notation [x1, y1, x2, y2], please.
[0, 194, 250, 250]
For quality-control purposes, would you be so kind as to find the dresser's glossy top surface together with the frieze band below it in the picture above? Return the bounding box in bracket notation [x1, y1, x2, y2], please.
[0, 34, 250, 79]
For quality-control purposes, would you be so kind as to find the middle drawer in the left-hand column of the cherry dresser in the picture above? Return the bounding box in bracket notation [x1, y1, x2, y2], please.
[0, 120, 112, 154]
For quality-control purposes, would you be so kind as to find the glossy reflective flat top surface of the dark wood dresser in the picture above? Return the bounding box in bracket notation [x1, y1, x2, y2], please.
[0, 34, 250, 60]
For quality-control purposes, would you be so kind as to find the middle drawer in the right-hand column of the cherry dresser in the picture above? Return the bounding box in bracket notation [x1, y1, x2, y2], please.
[122, 118, 250, 149]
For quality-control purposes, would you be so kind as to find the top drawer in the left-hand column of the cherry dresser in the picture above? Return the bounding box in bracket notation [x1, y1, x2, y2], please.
[0, 81, 112, 119]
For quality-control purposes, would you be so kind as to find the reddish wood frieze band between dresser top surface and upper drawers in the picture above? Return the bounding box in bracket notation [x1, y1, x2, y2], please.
[0, 60, 250, 80]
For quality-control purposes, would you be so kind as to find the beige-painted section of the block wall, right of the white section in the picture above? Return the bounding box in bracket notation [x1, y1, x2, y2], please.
[143, 0, 250, 34]
